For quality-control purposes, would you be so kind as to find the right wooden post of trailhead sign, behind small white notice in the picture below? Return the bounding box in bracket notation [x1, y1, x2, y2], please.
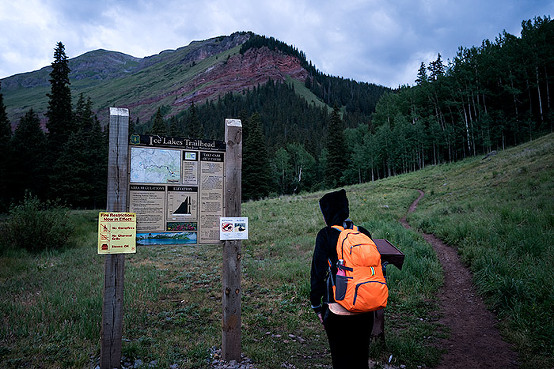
[221, 119, 242, 361]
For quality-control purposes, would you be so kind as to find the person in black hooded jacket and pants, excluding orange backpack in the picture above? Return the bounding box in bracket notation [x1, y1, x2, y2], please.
[310, 189, 373, 369]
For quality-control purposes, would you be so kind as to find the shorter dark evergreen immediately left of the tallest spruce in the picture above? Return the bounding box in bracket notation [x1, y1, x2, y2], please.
[8, 109, 47, 200]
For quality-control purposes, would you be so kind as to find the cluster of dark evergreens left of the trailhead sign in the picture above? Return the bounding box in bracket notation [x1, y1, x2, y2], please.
[0, 42, 108, 211]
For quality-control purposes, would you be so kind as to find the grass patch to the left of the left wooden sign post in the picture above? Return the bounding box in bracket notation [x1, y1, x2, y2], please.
[0, 208, 102, 367]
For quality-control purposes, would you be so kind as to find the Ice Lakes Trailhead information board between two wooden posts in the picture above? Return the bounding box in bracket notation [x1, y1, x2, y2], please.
[129, 135, 226, 245]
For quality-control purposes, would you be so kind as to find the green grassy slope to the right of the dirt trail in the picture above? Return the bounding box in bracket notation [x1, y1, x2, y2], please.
[411, 134, 554, 368]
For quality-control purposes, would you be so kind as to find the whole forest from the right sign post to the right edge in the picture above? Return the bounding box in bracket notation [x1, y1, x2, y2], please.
[140, 17, 554, 198]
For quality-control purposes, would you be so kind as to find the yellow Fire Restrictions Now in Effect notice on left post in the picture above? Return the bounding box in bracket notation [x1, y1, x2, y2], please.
[98, 212, 137, 254]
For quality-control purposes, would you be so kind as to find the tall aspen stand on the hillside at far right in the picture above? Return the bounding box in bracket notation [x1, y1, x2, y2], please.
[354, 17, 554, 180]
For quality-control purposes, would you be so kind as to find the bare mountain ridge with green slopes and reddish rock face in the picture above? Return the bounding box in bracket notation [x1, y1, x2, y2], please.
[0, 32, 386, 125]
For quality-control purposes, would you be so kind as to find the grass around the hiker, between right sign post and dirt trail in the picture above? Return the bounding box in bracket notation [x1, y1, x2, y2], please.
[239, 187, 442, 368]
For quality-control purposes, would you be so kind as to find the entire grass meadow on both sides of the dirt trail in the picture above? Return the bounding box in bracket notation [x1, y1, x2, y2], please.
[0, 134, 554, 369]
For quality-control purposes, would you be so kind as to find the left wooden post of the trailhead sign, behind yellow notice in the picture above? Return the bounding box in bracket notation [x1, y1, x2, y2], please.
[100, 108, 129, 369]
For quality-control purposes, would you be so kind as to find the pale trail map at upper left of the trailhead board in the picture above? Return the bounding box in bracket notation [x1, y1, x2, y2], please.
[131, 147, 181, 183]
